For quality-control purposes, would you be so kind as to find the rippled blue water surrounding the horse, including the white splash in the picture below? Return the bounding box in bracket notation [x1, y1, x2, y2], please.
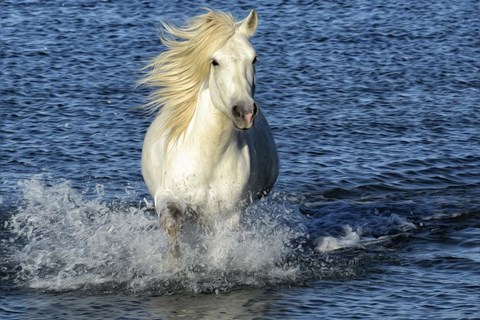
[0, 0, 480, 319]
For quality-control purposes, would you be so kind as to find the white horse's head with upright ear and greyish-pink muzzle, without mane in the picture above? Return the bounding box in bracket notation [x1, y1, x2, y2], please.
[209, 10, 259, 130]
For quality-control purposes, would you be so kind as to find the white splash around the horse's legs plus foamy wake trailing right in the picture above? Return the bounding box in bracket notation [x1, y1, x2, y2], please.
[6, 176, 416, 294]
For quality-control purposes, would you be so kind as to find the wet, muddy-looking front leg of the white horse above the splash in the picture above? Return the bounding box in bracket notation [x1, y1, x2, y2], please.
[156, 199, 185, 258]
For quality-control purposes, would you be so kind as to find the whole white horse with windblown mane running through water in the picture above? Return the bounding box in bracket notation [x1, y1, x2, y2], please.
[141, 10, 278, 254]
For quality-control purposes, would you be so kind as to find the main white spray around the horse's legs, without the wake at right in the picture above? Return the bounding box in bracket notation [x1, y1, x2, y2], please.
[9, 178, 303, 293]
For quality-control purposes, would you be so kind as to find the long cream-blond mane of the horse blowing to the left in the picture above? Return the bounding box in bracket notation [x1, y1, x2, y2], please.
[140, 11, 236, 142]
